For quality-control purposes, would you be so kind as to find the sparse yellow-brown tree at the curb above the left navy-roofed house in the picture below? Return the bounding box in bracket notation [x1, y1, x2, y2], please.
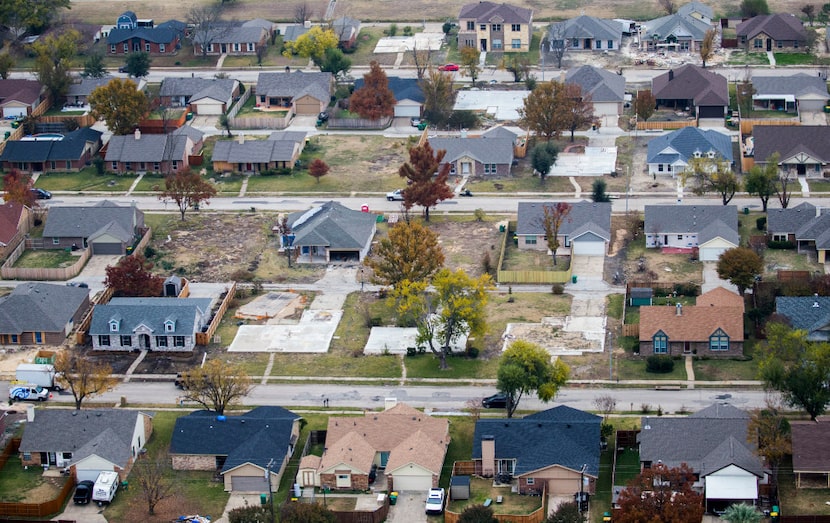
[181, 360, 251, 414]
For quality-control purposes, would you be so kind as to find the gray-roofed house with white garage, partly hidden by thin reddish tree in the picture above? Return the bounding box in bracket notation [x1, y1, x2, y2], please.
[516, 201, 611, 256]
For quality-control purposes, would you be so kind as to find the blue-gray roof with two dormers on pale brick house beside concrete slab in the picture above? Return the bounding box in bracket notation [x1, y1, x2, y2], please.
[89, 298, 212, 336]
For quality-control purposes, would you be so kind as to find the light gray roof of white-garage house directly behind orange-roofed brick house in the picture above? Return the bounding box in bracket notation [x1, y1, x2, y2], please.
[644, 205, 740, 245]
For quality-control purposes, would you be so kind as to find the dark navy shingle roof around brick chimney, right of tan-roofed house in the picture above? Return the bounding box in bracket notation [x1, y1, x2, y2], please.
[472, 411, 601, 477]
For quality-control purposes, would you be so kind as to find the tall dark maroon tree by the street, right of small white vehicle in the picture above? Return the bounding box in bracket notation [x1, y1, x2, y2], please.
[398, 141, 453, 221]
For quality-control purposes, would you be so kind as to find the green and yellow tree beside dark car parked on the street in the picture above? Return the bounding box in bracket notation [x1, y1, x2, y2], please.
[496, 340, 571, 418]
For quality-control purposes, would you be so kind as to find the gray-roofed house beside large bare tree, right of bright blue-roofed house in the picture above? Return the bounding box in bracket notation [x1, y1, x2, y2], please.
[193, 19, 271, 56]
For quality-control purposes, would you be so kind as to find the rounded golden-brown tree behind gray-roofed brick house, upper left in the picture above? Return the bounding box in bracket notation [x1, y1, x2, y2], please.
[88, 78, 150, 135]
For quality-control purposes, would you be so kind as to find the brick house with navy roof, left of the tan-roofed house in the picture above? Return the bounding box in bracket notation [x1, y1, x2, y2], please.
[170, 406, 301, 493]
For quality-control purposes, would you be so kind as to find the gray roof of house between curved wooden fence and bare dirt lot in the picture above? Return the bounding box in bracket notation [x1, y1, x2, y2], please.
[43, 200, 144, 242]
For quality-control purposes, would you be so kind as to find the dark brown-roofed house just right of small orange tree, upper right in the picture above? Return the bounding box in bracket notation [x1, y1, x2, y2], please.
[651, 64, 729, 119]
